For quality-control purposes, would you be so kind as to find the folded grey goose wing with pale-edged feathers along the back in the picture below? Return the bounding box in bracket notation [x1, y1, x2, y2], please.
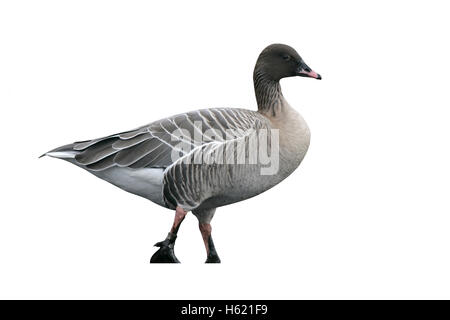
[71, 108, 267, 171]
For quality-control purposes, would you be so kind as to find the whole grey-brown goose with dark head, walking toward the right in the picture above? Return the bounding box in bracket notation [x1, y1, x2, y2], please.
[41, 44, 321, 263]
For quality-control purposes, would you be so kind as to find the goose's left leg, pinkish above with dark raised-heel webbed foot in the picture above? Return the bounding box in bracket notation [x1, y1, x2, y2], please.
[150, 207, 187, 263]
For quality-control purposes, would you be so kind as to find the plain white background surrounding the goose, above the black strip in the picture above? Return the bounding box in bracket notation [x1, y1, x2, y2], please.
[0, 0, 450, 299]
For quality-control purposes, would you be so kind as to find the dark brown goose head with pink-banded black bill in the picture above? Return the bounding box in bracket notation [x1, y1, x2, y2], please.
[255, 44, 322, 82]
